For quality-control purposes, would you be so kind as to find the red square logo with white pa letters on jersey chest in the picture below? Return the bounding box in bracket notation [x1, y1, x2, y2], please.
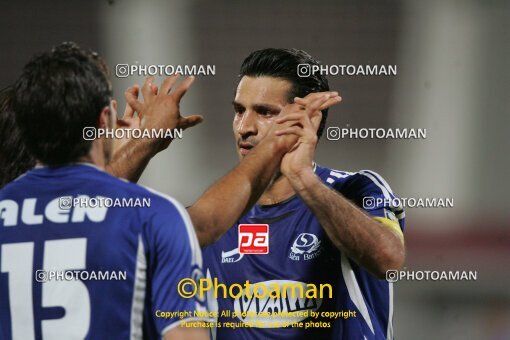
[238, 224, 269, 254]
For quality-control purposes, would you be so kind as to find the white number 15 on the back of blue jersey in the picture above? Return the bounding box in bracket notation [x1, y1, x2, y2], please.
[0, 238, 90, 340]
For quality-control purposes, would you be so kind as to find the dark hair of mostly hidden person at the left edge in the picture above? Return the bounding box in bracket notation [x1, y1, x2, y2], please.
[0, 86, 35, 188]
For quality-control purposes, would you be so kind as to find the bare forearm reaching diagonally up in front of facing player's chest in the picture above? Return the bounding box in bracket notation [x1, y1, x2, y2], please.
[188, 139, 285, 246]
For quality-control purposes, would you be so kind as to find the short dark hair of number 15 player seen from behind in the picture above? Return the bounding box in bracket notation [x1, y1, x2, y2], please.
[14, 43, 112, 166]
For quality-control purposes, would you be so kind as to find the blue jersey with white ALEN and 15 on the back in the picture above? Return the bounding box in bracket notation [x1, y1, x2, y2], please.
[0, 164, 205, 340]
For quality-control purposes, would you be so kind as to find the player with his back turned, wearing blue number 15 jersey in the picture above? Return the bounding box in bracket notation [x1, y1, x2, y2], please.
[0, 44, 208, 340]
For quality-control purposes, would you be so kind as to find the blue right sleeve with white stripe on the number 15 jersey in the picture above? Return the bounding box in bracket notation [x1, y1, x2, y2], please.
[143, 194, 210, 336]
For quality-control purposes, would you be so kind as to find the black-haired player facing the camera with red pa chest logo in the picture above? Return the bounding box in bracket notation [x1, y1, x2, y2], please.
[203, 49, 405, 340]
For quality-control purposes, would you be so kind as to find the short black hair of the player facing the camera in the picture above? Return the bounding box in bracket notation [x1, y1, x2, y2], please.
[239, 48, 329, 138]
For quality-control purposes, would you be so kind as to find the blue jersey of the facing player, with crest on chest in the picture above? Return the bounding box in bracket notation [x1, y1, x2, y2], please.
[203, 166, 404, 340]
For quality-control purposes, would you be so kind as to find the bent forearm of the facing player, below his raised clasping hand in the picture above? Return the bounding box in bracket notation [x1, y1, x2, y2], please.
[290, 171, 405, 278]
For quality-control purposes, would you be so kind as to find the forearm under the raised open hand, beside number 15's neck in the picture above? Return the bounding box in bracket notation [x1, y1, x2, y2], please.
[106, 138, 160, 183]
